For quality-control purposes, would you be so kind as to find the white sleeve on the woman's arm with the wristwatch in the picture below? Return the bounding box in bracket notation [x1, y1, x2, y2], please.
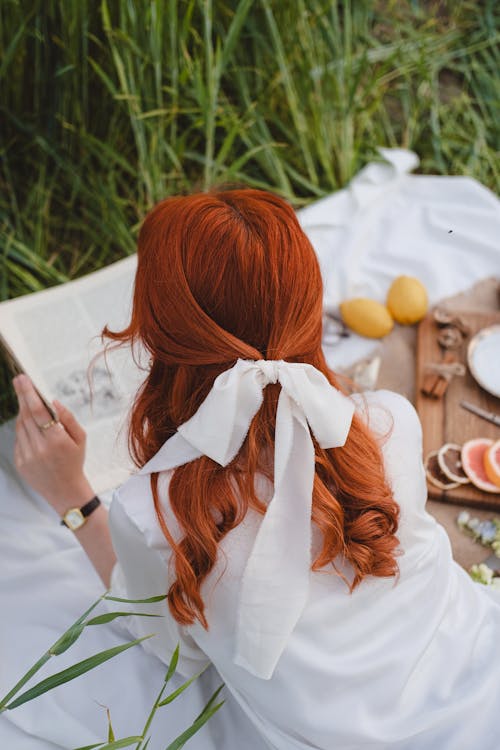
[106, 493, 209, 677]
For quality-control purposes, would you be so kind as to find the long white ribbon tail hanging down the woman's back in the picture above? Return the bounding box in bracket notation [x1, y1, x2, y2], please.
[233, 389, 314, 679]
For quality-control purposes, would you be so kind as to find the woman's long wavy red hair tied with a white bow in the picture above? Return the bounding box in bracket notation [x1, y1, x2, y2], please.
[103, 189, 399, 627]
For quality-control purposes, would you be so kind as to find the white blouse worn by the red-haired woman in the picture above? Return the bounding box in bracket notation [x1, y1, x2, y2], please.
[110, 391, 500, 750]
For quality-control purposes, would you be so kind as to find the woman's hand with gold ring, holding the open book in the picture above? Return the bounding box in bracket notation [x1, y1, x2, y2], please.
[13, 375, 95, 516]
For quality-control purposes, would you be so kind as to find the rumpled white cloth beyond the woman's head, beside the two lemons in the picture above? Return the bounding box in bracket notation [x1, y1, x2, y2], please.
[297, 148, 500, 369]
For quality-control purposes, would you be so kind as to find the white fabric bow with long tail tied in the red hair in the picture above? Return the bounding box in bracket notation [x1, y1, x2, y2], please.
[139, 359, 354, 679]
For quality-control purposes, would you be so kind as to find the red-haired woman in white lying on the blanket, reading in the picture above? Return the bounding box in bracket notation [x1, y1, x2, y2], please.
[5, 190, 500, 750]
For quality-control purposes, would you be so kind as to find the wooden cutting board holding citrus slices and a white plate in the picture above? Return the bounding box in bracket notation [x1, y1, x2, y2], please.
[416, 310, 500, 511]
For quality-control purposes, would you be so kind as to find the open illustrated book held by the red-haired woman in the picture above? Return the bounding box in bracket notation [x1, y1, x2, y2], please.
[0, 255, 147, 493]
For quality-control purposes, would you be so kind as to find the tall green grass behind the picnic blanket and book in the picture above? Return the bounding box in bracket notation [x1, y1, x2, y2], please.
[0, 0, 500, 419]
